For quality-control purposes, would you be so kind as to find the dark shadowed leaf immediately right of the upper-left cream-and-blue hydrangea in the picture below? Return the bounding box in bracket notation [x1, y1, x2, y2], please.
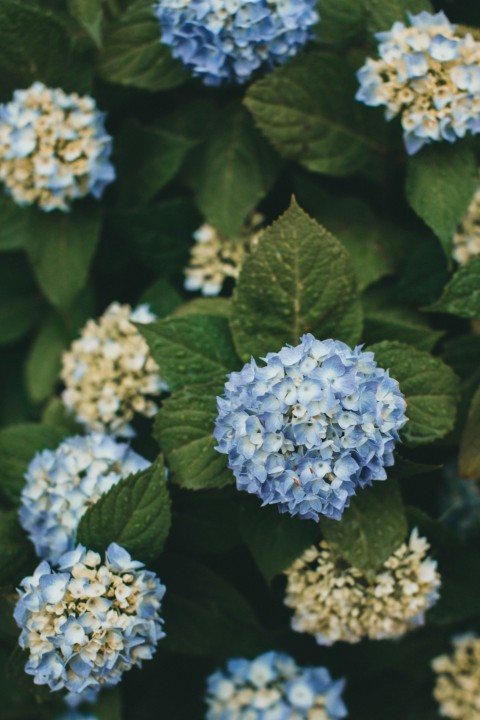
[115, 120, 196, 207]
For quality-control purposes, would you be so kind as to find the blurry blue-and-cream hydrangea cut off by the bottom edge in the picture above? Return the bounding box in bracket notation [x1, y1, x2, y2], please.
[206, 651, 347, 720]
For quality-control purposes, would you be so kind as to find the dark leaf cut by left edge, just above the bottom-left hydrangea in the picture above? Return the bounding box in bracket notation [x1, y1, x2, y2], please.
[0, 510, 36, 586]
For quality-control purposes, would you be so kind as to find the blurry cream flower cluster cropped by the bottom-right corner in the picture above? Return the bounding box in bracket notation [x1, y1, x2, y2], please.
[432, 634, 480, 720]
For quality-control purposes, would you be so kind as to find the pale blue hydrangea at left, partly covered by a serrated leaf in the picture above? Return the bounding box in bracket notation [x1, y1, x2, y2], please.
[19, 434, 150, 562]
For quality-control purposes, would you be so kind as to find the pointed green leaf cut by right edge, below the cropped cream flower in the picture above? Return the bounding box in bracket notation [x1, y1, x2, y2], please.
[426, 258, 480, 320]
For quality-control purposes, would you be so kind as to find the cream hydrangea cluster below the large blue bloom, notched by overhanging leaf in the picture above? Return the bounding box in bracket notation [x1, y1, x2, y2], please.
[285, 530, 440, 645]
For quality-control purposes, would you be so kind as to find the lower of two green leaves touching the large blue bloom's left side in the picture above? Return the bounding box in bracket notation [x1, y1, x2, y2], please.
[155, 383, 234, 490]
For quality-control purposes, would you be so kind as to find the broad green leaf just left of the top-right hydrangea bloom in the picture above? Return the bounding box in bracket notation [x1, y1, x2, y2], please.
[245, 52, 384, 175]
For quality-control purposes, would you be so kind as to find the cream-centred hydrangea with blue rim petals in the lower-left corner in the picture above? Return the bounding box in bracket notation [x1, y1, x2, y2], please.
[15, 543, 165, 700]
